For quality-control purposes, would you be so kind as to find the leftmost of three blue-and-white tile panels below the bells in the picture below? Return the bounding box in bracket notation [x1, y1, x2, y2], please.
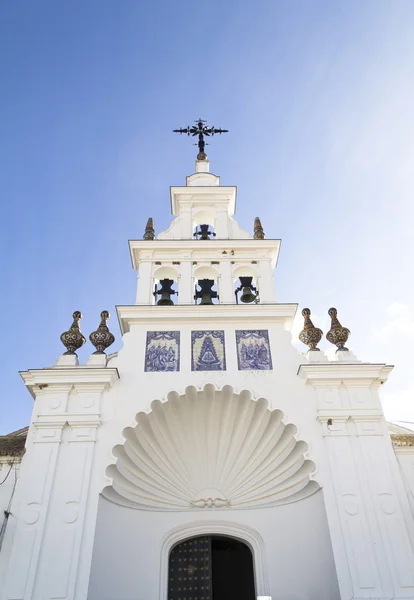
[145, 331, 180, 371]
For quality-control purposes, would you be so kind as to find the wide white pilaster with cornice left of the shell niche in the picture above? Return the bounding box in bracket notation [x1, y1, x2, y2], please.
[3, 367, 118, 600]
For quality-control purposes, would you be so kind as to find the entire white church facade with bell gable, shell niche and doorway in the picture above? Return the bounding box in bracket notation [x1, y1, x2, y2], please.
[0, 127, 414, 600]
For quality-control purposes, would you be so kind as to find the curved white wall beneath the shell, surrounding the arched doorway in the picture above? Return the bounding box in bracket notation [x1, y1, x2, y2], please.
[88, 492, 340, 600]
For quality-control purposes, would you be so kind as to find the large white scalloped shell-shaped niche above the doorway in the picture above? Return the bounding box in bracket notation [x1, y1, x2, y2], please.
[103, 384, 320, 510]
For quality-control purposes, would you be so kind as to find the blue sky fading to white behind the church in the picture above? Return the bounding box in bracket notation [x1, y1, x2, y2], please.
[0, 0, 414, 433]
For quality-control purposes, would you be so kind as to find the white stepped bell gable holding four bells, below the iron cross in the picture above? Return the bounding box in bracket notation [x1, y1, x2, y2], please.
[129, 154, 280, 306]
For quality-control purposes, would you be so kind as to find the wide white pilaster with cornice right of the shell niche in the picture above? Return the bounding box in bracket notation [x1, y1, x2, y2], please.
[299, 362, 414, 600]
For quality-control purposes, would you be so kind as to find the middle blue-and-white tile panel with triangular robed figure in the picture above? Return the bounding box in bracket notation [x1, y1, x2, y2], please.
[191, 331, 226, 371]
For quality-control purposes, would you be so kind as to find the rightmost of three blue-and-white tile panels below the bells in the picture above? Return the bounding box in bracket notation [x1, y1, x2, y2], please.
[236, 329, 272, 371]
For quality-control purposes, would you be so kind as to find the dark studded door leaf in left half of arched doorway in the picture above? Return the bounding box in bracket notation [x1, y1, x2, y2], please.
[168, 536, 212, 600]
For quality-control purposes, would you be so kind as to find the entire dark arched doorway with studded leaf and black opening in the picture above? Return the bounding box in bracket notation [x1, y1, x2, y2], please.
[168, 535, 255, 600]
